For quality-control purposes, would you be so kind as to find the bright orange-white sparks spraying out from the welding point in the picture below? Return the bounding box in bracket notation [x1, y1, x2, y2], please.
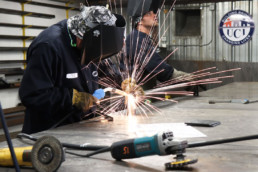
[81, 0, 243, 128]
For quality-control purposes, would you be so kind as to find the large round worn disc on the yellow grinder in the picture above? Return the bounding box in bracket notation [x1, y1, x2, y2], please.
[31, 136, 64, 172]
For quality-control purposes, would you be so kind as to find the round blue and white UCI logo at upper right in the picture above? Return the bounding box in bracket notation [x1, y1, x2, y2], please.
[219, 10, 255, 45]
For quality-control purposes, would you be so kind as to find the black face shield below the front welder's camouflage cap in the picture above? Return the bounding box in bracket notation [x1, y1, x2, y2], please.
[81, 25, 125, 64]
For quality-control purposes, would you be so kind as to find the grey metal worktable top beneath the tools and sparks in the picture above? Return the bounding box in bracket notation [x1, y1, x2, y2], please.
[0, 82, 258, 172]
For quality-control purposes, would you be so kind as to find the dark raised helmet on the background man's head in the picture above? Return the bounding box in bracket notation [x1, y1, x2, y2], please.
[127, 0, 161, 28]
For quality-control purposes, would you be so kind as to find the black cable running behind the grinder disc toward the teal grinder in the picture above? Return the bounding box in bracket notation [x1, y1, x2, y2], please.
[17, 133, 108, 150]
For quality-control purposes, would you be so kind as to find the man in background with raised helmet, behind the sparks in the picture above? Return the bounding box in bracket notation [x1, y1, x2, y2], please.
[126, 0, 189, 89]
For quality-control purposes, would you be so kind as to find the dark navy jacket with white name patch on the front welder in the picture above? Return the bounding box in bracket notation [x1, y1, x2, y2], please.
[19, 20, 98, 133]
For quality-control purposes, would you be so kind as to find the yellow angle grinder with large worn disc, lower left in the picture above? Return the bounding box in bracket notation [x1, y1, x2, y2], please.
[0, 136, 65, 172]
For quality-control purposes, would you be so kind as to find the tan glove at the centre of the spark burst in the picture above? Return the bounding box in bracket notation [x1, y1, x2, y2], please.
[121, 78, 144, 96]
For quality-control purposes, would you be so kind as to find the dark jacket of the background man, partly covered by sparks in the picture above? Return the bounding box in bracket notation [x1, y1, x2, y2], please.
[126, 29, 174, 82]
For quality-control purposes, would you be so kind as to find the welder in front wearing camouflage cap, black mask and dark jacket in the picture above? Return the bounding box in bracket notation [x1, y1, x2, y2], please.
[19, 4, 125, 134]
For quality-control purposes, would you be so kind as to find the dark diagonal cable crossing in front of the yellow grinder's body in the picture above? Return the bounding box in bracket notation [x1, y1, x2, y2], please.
[0, 103, 20, 172]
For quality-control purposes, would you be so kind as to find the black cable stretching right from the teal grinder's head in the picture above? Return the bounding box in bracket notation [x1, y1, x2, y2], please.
[188, 135, 258, 148]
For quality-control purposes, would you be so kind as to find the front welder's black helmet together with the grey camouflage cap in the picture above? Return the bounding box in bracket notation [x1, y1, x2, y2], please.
[67, 4, 126, 65]
